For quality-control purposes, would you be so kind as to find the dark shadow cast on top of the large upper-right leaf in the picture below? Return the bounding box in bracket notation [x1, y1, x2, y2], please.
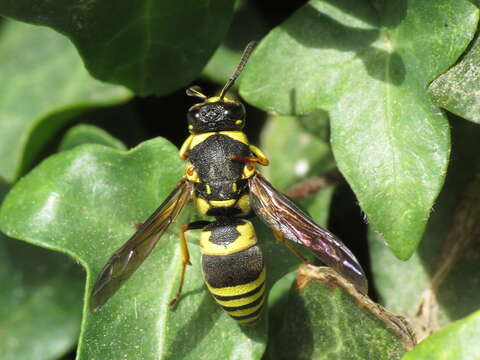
[282, 0, 406, 86]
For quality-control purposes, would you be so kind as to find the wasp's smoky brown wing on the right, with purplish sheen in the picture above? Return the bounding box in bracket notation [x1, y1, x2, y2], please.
[249, 173, 368, 294]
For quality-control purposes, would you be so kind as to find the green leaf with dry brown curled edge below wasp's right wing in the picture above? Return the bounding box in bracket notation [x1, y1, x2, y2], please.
[269, 266, 414, 360]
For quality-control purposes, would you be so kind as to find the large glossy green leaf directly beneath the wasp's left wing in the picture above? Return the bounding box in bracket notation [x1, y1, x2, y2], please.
[0, 139, 266, 360]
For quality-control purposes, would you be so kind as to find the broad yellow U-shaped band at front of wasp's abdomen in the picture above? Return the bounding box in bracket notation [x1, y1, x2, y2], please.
[200, 222, 257, 256]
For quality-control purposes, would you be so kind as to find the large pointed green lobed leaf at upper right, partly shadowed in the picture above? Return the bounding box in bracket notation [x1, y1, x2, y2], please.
[240, 0, 478, 260]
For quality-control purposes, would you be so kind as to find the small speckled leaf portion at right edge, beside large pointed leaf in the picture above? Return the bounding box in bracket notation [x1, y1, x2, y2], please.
[428, 34, 480, 124]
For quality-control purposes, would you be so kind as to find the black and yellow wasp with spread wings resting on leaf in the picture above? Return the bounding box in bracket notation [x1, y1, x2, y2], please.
[90, 42, 367, 323]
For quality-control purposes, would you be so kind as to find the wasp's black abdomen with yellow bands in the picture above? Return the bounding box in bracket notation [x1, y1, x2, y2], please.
[200, 218, 266, 323]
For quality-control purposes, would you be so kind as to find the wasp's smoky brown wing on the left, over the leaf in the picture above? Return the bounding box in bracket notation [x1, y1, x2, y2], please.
[90, 179, 193, 312]
